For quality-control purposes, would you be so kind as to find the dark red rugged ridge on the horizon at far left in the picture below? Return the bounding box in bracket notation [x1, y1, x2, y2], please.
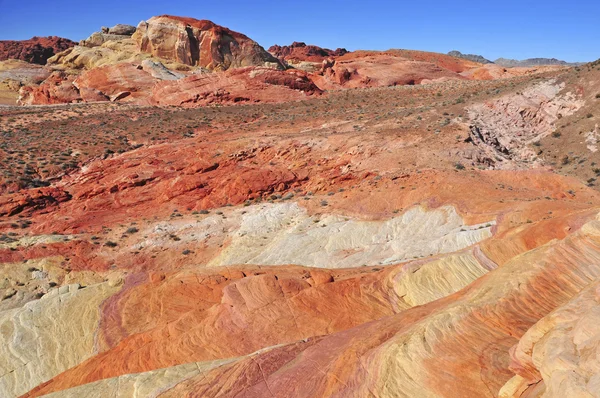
[0, 36, 77, 65]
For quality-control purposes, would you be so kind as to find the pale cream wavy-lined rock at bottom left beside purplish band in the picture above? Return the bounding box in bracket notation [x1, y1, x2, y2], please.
[0, 283, 117, 397]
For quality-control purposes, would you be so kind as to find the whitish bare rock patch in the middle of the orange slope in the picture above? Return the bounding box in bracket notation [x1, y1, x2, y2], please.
[211, 204, 492, 268]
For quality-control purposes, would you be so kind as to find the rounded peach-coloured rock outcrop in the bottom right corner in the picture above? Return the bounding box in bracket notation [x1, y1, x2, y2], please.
[499, 274, 600, 398]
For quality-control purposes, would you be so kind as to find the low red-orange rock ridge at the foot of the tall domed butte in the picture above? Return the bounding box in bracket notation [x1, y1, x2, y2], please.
[19, 63, 321, 107]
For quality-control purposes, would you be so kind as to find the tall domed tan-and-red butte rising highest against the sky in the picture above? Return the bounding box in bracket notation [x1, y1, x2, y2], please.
[133, 15, 278, 70]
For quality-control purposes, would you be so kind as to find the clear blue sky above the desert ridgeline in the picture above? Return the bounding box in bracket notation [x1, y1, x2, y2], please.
[0, 0, 600, 61]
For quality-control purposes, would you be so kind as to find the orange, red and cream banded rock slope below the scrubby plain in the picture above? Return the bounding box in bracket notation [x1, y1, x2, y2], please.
[0, 83, 600, 397]
